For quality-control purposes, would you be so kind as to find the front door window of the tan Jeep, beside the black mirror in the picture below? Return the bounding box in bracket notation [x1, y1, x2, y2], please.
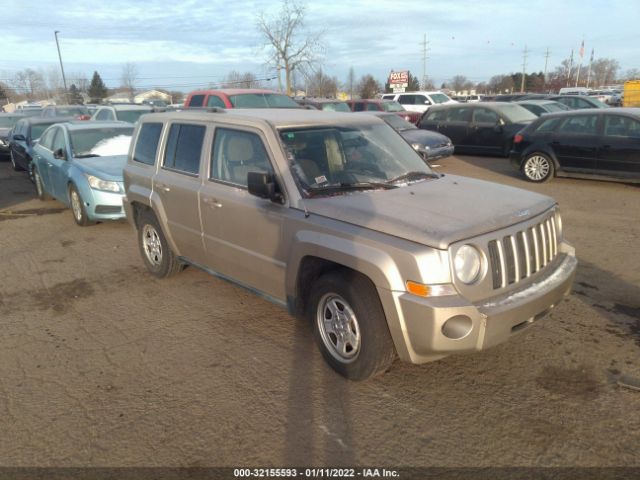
[211, 128, 273, 186]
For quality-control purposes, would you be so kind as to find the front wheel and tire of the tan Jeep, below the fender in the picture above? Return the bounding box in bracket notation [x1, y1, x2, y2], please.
[309, 270, 396, 380]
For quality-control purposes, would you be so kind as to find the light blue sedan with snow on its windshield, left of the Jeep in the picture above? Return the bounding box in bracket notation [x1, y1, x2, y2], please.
[33, 122, 133, 226]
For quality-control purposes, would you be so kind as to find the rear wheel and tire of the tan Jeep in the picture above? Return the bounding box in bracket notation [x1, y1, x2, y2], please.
[138, 211, 184, 278]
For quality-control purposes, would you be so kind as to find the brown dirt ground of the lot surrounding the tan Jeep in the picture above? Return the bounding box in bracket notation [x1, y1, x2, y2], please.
[0, 156, 640, 466]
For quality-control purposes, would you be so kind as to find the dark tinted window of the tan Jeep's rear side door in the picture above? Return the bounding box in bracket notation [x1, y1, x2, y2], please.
[164, 123, 206, 175]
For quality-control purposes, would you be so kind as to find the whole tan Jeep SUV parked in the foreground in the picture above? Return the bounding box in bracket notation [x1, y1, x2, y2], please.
[124, 109, 576, 379]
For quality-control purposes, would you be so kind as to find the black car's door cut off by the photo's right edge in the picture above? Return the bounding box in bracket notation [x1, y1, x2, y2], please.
[597, 115, 640, 178]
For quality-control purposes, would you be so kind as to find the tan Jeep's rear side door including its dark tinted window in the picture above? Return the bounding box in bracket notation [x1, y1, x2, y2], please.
[153, 122, 207, 263]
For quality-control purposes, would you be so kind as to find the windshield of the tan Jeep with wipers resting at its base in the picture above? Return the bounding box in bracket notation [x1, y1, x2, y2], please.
[280, 124, 435, 197]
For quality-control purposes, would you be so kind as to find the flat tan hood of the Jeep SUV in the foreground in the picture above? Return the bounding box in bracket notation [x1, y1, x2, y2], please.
[304, 175, 555, 249]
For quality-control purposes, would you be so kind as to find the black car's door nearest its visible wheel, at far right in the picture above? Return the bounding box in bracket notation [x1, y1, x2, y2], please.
[551, 114, 602, 170]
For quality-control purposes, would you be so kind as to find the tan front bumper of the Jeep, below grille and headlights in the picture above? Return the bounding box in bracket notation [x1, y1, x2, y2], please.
[381, 245, 577, 363]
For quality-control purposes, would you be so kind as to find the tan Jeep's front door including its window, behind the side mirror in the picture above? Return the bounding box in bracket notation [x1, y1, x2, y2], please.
[200, 128, 286, 301]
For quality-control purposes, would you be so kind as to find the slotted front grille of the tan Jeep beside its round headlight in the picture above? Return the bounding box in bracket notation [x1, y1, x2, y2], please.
[488, 216, 559, 289]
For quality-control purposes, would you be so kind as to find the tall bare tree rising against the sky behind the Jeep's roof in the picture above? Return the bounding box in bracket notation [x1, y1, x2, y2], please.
[257, 0, 324, 95]
